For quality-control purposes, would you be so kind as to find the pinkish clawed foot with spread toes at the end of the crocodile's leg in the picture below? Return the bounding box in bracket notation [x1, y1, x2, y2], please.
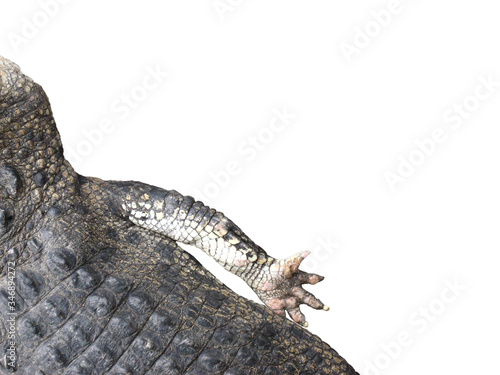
[255, 251, 330, 327]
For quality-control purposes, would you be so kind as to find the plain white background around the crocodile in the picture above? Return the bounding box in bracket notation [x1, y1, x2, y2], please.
[0, 0, 500, 375]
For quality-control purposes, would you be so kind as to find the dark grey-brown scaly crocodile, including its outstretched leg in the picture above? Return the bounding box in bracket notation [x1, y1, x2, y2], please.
[0, 57, 357, 375]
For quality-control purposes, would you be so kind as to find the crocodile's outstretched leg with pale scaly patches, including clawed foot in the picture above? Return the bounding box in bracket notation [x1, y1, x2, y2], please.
[106, 181, 328, 326]
